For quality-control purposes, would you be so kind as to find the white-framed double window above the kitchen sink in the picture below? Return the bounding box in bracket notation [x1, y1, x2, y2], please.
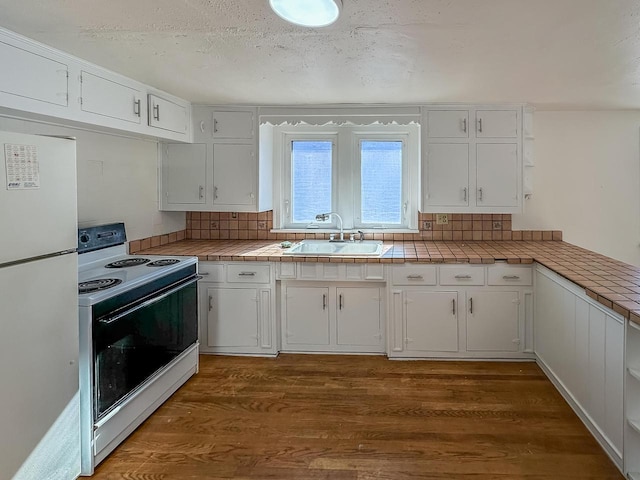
[274, 124, 420, 231]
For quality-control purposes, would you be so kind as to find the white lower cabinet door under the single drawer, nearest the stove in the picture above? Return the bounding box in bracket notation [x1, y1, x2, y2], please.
[207, 288, 259, 347]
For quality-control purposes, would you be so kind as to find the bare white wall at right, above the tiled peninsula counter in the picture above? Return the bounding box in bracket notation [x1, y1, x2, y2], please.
[513, 111, 640, 266]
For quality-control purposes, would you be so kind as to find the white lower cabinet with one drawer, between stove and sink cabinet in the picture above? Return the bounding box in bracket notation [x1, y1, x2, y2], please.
[199, 262, 278, 355]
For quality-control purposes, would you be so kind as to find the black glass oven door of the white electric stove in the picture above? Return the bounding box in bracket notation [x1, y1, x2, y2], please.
[93, 277, 198, 420]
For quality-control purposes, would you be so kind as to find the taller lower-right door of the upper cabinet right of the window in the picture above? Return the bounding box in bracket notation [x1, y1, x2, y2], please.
[476, 143, 519, 207]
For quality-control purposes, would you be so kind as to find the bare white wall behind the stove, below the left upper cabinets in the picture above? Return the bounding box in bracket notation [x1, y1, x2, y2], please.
[0, 117, 186, 240]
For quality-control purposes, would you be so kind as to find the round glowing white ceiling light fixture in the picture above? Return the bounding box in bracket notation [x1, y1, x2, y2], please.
[269, 0, 342, 27]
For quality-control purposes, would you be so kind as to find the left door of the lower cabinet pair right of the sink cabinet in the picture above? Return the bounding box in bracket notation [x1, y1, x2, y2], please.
[405, 290, 459, 352]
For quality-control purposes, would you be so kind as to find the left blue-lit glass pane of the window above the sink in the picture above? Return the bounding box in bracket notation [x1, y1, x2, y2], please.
[291, 140, 333, 223]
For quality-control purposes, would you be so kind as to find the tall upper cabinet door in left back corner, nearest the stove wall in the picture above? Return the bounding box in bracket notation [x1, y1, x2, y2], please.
[162, 144, 207, 205]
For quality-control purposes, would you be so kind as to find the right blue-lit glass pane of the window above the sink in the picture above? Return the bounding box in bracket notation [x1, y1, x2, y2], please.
[360, 141, 402, 224]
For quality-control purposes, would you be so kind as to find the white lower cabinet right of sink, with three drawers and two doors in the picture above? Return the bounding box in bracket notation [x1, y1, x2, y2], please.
[388, 264, 533, 358]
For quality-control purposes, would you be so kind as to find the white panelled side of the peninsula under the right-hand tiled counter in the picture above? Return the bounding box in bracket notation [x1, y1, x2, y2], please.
[535, 266, 620, 468]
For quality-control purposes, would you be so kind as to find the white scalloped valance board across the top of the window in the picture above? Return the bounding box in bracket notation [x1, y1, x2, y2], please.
[258, 105, 421, 126]
